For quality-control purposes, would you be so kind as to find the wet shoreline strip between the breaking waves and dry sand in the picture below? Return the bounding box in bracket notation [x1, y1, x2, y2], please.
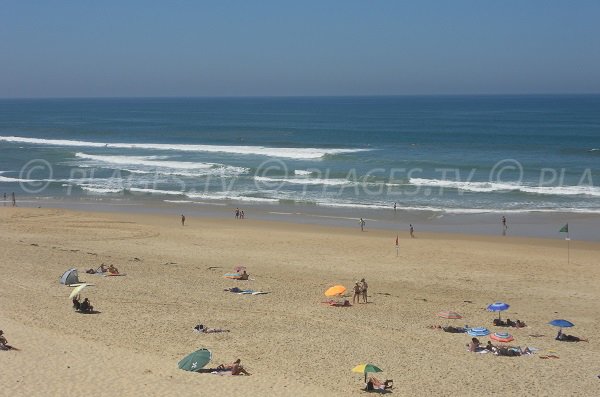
[6, 197, 600, 242]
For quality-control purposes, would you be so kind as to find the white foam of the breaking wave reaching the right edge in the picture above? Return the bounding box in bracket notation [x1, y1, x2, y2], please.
[410, 178, 600, 197]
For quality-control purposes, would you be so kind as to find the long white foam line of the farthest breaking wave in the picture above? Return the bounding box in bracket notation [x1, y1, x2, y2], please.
[0, 136, 371, 159]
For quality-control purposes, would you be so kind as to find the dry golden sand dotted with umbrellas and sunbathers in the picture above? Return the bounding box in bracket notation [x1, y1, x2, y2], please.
[0, 207, 600, 396]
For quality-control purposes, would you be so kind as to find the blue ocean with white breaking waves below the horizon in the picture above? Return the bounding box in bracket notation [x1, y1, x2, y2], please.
[0, 95, 600, 229]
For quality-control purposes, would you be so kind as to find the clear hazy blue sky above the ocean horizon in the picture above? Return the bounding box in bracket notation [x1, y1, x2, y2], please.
[0, 0, 600, 97]
